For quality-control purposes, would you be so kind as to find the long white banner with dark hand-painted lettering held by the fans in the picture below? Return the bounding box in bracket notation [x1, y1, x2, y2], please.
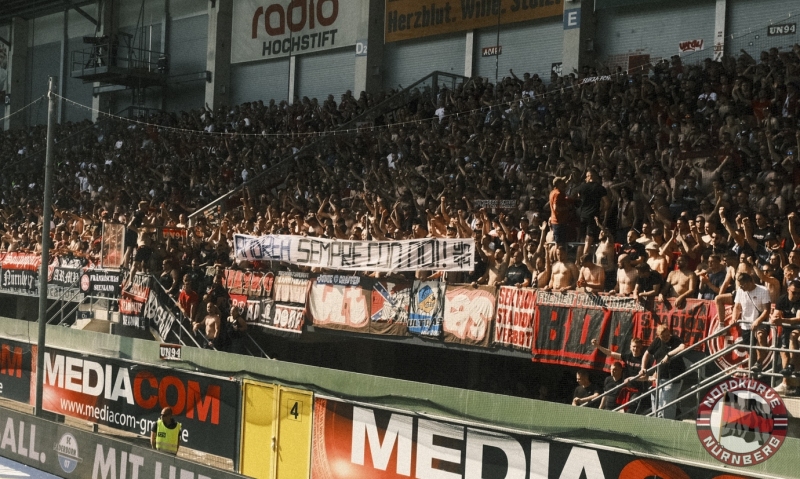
[234, 234, 475, 272]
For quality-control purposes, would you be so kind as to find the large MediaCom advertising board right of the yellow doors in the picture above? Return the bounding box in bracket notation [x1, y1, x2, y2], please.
[311, 398, 745, 479]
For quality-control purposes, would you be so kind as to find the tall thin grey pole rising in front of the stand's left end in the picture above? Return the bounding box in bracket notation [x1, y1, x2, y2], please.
[34, 76, 58, 417]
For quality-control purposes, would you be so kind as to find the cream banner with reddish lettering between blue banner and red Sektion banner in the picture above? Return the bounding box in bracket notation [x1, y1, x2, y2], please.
[442, 284, 497, 348]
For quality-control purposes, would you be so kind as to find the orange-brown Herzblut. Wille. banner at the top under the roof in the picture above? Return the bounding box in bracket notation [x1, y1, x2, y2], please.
[385, 0, 564, 43]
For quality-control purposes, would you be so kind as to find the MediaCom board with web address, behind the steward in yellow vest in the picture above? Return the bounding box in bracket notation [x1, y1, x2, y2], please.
[37, 348, 240, 459]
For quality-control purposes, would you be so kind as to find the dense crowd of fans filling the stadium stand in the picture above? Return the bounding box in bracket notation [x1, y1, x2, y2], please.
[0, 45, 800, 408]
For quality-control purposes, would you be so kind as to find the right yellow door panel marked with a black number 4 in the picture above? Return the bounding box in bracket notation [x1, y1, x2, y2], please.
[275, 387, 313, 479]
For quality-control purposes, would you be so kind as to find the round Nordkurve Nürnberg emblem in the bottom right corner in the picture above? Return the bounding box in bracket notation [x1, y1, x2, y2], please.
[697, 378, 789, 466]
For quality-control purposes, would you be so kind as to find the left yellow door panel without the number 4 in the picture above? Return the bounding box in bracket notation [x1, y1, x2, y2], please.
[240, 381, 277, 479]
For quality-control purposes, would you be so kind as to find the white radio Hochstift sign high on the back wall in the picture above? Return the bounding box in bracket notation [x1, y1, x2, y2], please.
[231, 0, 358, 63]
